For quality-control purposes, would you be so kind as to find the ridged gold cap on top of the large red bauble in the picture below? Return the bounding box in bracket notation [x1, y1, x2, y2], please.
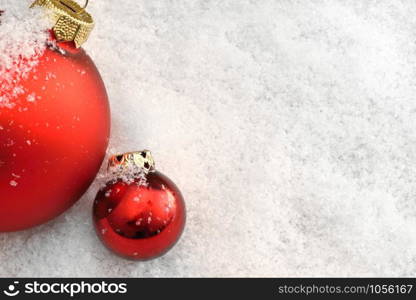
[31, 0, 94, 48]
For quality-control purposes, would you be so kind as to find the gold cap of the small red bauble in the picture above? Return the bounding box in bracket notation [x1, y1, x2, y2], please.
[108, 150, 155, 171]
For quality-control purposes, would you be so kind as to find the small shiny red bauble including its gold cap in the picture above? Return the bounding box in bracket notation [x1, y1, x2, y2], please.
[93, 151, 185, 260]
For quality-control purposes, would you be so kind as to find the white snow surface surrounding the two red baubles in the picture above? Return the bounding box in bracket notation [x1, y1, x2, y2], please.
[0, 0, 416, 277]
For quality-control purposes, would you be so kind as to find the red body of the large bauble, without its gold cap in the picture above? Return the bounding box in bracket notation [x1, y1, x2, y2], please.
[0, 43, 110, 232]
